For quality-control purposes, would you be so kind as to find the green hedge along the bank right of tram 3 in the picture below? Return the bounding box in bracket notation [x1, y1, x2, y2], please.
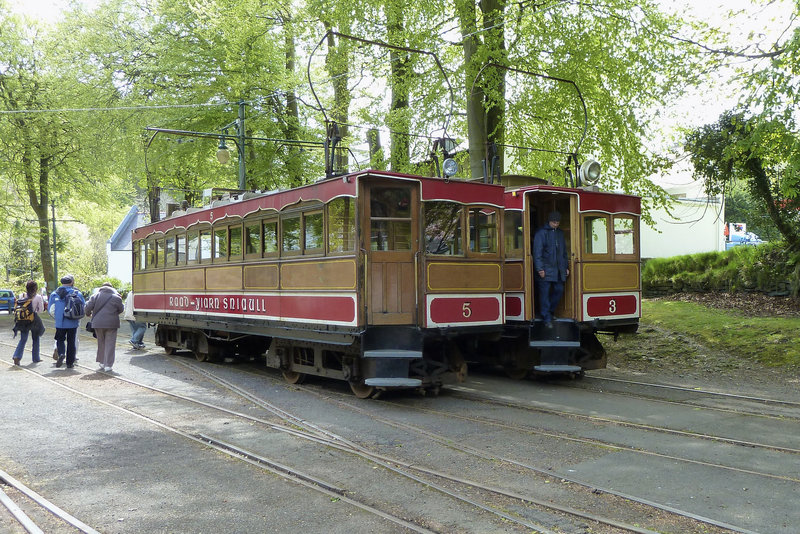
[642, 242, 800, 296]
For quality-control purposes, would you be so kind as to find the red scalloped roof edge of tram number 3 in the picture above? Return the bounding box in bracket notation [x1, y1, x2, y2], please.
[505, 184, 642, 215]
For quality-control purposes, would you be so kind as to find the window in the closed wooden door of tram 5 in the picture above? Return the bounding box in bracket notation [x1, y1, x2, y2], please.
[370, 187, 411, 250]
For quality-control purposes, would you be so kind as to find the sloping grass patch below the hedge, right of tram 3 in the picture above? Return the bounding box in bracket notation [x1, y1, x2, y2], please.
[637, 300, 800, 366]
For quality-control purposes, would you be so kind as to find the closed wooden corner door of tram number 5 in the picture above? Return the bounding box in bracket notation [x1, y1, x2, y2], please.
[365, 183, 419, 325]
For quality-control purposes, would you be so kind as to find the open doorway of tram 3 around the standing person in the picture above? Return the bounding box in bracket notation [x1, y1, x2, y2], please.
[527, 197, 578, 319]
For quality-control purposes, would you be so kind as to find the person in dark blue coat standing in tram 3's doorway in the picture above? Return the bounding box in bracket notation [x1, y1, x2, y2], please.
[533, 211, 569, 326]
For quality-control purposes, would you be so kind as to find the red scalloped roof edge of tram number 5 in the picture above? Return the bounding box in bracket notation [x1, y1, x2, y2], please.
[133, 170, 505, 239]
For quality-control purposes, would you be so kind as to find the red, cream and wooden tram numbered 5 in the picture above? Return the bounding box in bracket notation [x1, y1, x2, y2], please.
[133, 171, 509, 397]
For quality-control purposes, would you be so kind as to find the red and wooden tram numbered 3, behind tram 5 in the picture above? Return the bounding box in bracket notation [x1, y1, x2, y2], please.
[462, 177, 641, 378]
